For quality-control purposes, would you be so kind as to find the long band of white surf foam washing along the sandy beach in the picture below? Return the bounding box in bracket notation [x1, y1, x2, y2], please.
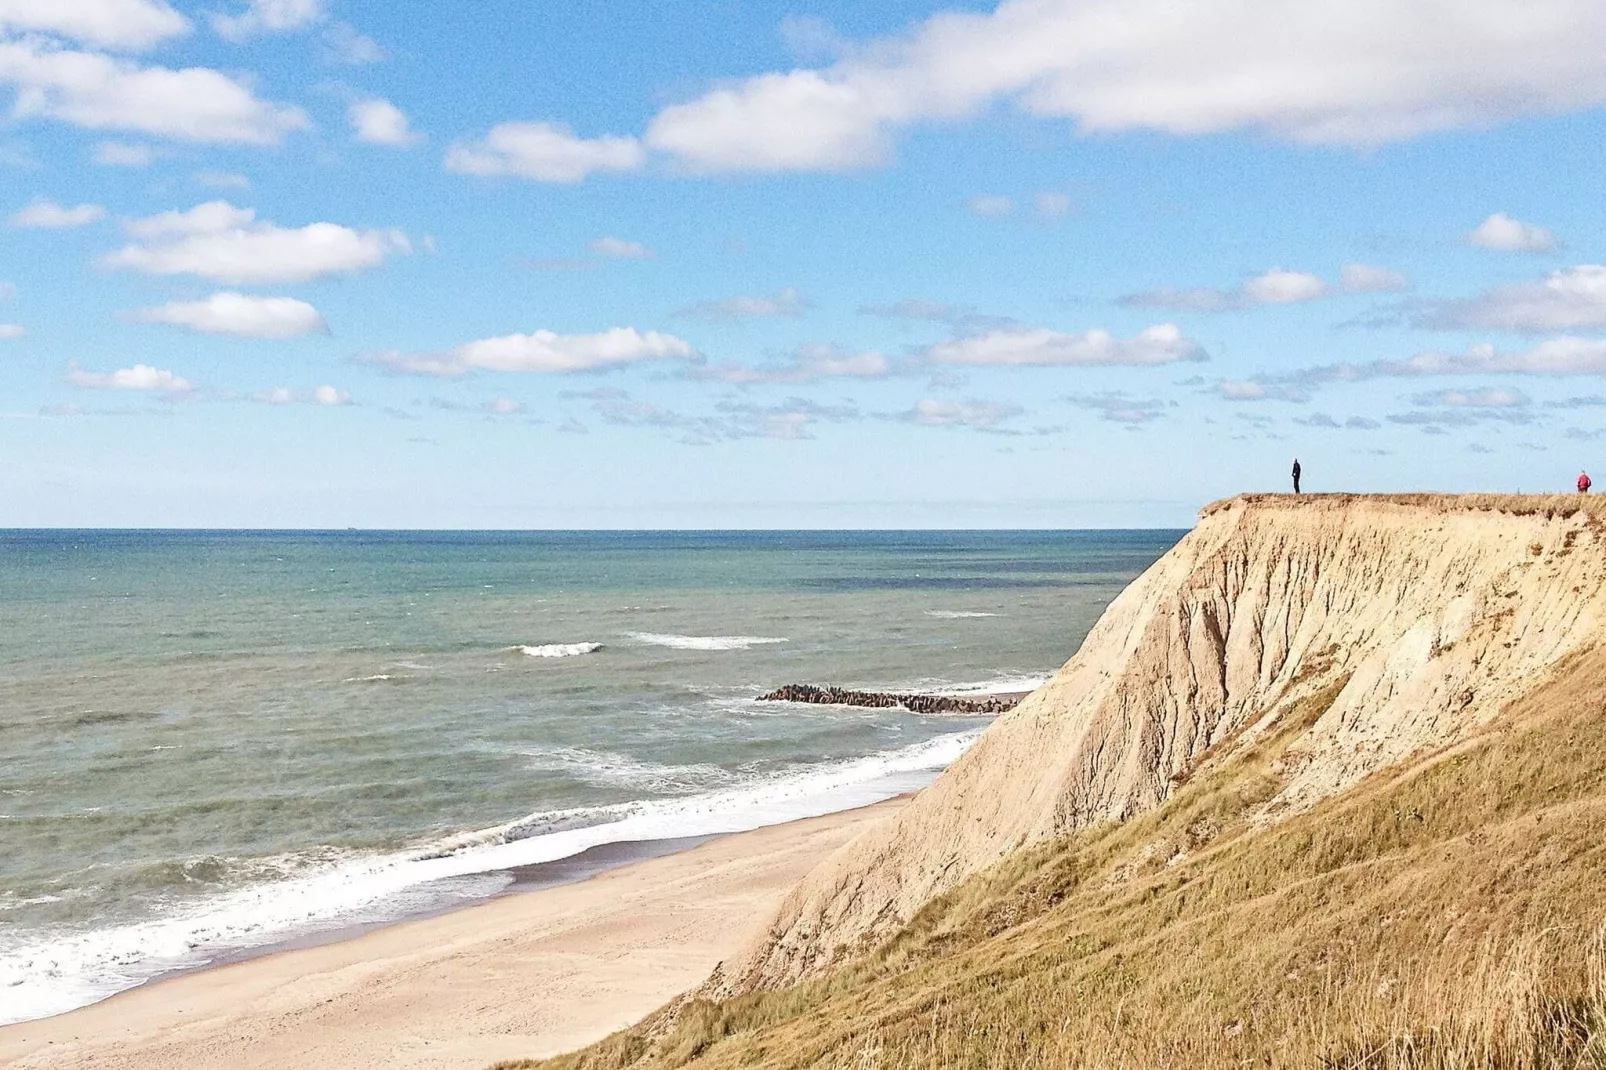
[0, 729, 980, 1025]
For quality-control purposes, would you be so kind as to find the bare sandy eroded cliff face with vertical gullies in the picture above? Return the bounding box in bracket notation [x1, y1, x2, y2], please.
[708, 495, 1606, 994]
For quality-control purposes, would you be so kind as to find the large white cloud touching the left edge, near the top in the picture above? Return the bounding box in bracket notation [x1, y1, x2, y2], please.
[0, 39, 310, 145]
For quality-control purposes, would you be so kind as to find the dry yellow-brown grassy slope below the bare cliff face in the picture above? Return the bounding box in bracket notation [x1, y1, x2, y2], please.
[511, 651, 1606, 1070]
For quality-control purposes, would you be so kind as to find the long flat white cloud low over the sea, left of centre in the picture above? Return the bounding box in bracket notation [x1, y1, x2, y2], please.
[361, 328, 697, 376]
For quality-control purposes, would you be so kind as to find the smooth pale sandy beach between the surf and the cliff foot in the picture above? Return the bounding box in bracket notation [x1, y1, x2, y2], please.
[0, 800, 903, 1070]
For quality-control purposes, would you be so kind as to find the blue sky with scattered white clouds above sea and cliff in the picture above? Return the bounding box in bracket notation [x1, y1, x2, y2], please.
[0, 0, 1606, 529]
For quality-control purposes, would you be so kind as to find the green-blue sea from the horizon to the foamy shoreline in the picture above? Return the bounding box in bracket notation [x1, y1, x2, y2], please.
[0, 530, 1182, 1023]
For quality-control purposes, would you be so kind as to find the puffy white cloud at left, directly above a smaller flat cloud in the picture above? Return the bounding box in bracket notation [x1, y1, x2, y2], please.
[101, 201, 411, 283]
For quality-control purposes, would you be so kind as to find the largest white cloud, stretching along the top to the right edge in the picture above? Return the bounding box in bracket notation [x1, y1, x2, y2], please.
[635, 0, 1606, 172]
